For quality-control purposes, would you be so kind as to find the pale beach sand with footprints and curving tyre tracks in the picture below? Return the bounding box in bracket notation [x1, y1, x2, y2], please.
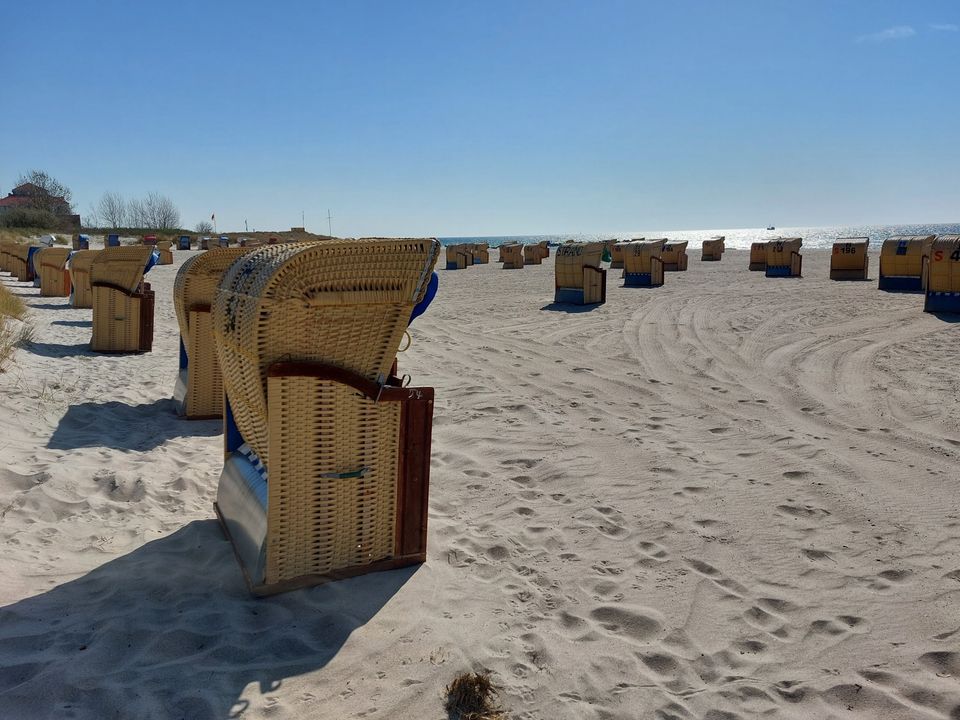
[0, 245, 960, 720]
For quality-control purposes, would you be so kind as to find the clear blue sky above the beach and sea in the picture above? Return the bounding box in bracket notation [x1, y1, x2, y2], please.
[0, 0, 960, 236]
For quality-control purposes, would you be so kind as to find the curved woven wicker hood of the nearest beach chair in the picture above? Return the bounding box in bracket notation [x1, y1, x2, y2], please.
[213, 238, 440, 468]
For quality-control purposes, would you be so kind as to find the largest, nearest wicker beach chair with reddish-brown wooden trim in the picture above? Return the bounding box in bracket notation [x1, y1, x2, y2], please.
[213, 239, 440, 595]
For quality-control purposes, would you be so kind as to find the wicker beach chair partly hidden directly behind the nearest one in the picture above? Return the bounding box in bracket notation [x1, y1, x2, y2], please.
[173, 248, 252, 420]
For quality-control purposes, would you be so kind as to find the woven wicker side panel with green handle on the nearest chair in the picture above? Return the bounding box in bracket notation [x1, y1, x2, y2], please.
[265, 376, 401, 584]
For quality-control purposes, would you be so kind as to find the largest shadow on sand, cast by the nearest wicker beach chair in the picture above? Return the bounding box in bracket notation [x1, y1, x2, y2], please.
[0, 520, 416, 718]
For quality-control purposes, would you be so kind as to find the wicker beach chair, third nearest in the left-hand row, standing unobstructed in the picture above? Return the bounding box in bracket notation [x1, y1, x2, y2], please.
[90, 245, 155, 353]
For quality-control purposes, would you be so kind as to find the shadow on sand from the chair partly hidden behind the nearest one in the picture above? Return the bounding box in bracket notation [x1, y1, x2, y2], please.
[47, 400, 223, 451]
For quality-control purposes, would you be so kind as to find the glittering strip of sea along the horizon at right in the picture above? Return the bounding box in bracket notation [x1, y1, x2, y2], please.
[440, 223, 960, 250]
